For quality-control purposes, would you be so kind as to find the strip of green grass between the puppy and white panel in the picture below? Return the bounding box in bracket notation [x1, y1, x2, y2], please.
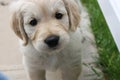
[82, 0, 120, 80]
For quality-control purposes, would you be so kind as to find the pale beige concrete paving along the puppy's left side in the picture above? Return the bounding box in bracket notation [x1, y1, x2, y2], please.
[0, 0, 27, 80]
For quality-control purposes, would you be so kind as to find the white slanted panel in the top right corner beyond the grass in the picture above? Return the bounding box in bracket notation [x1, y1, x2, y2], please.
[98, 0, 120, 51]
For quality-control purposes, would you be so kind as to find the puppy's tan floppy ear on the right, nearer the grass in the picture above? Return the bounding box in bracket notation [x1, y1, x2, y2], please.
[63, 0, 80, 31]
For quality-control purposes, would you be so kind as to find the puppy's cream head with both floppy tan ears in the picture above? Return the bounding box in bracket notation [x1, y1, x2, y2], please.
[11, 0, 80, 52]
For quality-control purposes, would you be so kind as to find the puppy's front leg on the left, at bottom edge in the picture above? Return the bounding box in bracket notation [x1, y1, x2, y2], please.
[27, 70, 46, 80]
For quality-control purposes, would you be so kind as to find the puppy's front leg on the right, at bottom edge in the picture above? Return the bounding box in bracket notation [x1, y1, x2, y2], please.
[62, 67, 81, 80]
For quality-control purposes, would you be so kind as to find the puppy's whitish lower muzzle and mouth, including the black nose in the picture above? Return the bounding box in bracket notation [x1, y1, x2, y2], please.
[34, 35, 69, 54]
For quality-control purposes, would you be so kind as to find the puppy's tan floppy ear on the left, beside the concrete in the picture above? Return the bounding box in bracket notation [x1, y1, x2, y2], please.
[10, 3, 28, 45]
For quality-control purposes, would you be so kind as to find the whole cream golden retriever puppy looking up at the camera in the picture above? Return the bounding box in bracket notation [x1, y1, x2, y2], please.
[10, 0, 103, 80]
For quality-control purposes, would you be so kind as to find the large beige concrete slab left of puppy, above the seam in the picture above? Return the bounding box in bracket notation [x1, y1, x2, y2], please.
[0, 0, 22, 65]
